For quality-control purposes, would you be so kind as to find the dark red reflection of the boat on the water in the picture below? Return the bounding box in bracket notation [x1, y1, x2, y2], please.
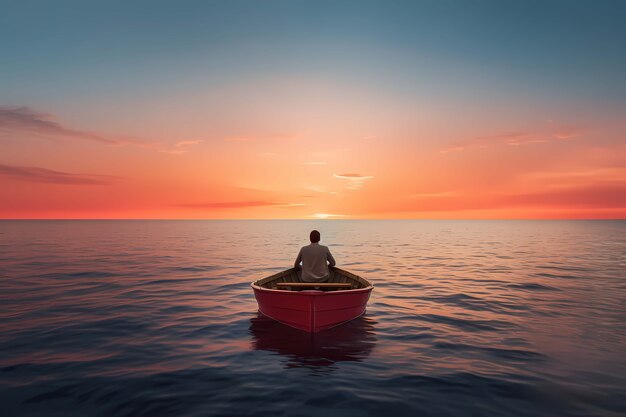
[250, 313, 376, 368]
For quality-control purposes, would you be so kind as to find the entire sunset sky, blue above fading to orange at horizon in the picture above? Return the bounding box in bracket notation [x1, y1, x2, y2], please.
[0, 0, 626, 219]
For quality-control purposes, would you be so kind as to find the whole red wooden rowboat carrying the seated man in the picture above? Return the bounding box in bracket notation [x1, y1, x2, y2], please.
[251, 268, 374, 333]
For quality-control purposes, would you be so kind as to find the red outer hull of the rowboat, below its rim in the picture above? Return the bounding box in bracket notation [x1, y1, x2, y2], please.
[252, 285, 372, 333]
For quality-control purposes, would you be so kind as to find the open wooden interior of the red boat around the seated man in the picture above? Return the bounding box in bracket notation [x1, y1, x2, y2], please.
[253, 268, 372, 291]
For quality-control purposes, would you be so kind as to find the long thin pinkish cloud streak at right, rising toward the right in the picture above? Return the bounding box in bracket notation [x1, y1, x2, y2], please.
[439, 127, 585, 153]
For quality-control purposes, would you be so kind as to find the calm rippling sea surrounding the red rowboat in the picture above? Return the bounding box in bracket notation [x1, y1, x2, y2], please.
[0, 220, 626, 417]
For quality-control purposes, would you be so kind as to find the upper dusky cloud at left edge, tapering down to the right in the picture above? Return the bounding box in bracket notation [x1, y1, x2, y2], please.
[0, 106, 124, 145]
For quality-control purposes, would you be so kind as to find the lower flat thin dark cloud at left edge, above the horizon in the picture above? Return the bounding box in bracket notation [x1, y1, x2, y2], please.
[0, 164, 120, 185]
